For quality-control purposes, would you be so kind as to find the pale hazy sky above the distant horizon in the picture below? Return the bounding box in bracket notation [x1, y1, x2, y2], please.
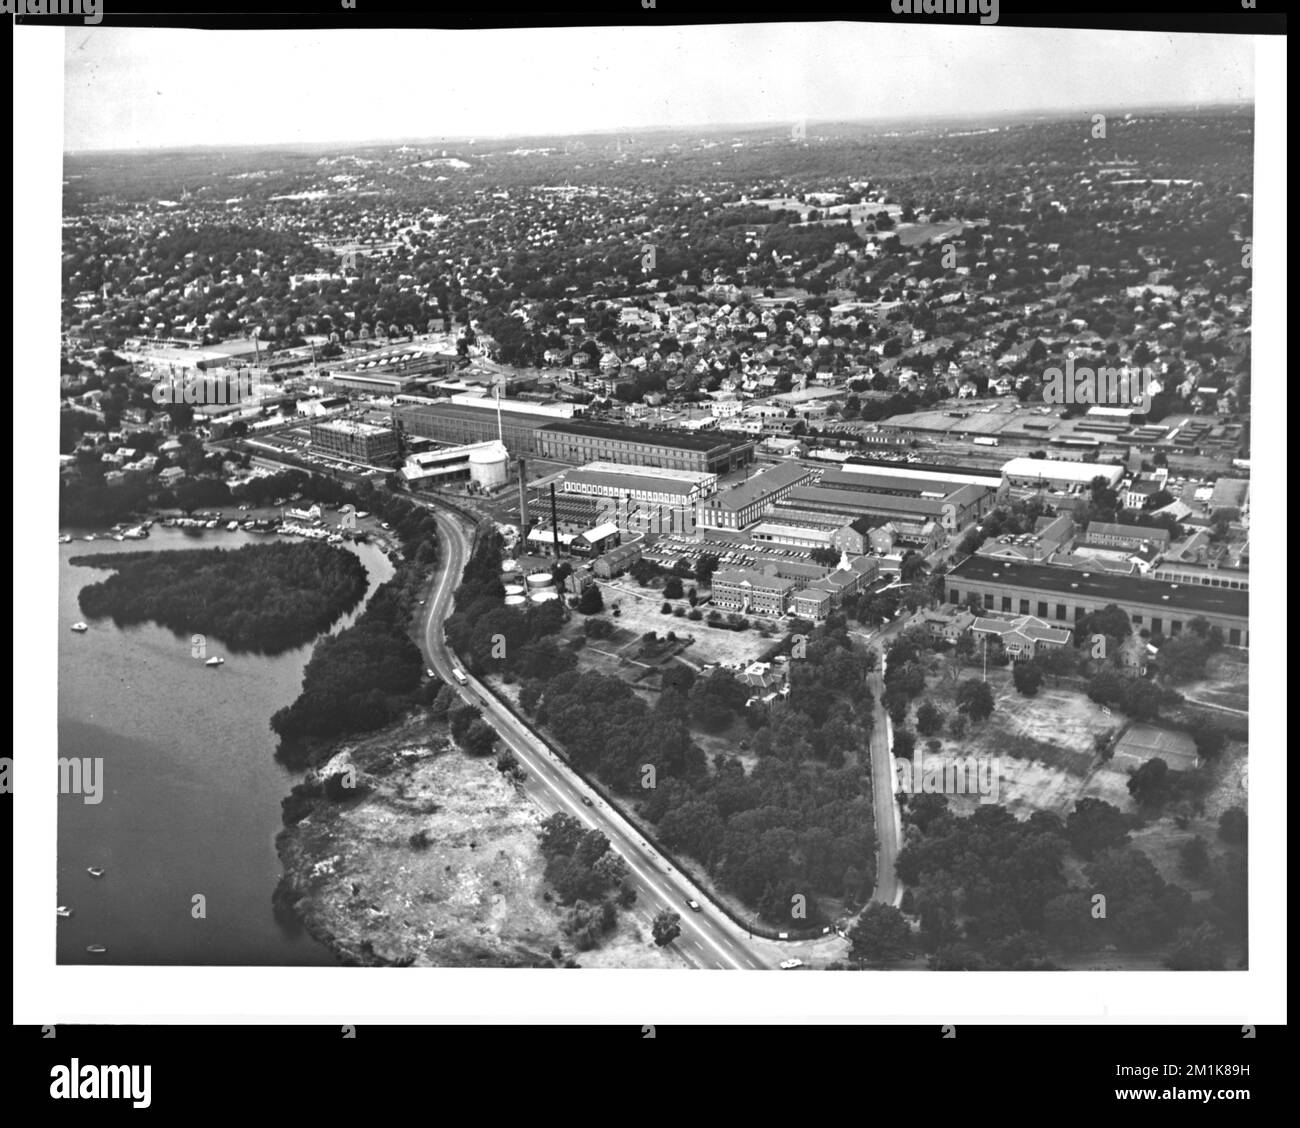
[64, 22, 1255, 149]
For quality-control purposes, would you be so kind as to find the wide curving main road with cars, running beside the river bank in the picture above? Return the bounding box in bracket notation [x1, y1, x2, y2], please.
[423, 504, 774, 969]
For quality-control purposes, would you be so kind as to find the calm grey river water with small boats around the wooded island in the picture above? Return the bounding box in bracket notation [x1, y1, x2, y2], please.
[59, 526, 394, 966]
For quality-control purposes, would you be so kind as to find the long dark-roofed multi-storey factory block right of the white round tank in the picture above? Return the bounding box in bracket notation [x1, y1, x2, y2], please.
[536, 420, 755, 474]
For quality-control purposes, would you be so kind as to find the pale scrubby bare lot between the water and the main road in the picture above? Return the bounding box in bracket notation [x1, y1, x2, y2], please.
[277, 721, 679, 967]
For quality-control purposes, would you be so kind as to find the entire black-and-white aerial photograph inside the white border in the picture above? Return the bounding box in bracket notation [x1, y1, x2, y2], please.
[55, 19, 1266, 982]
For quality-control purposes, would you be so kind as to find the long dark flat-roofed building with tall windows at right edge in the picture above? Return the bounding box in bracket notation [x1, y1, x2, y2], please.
[944, 555, 1251, 647]
